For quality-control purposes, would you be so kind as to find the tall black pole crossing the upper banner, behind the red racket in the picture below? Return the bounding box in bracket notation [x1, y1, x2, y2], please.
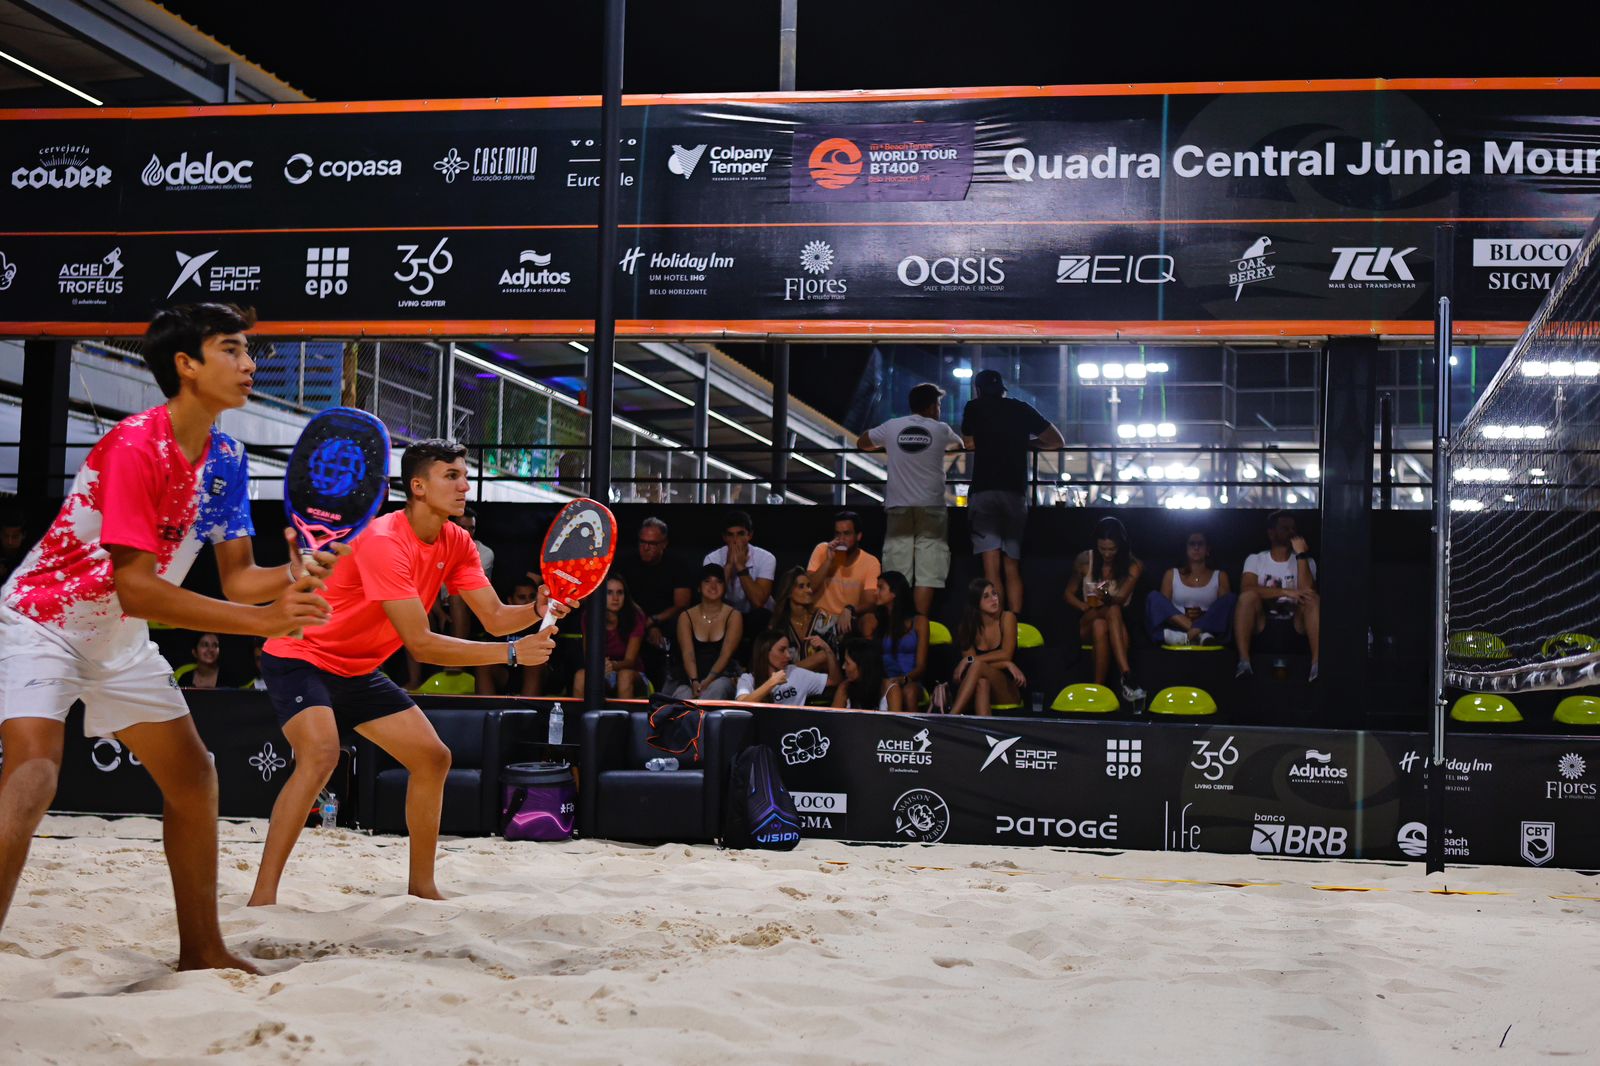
[584, 0, 627, 707]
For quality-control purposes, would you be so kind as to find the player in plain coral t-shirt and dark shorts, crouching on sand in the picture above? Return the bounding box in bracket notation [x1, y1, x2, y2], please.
[250, 440, 570, 906]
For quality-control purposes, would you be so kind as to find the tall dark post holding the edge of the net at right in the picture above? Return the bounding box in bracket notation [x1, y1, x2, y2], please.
[1424, 226, 1456, 874]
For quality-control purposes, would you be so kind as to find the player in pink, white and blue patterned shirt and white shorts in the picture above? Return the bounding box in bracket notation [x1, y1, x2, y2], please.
[0, 304, 333, 972]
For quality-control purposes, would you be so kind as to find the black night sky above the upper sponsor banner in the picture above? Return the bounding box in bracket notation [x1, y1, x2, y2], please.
[165, 0, 1597, 99]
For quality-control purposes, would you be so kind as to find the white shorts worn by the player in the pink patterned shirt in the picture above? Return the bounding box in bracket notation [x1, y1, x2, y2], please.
[0, 607, 189, 736]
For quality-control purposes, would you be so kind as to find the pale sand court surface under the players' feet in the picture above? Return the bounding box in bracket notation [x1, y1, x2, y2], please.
[0, 816, 1600, 1064]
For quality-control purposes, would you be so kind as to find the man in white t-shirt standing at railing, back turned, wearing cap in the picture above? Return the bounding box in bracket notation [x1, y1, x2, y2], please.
[856, 381, 962, 615]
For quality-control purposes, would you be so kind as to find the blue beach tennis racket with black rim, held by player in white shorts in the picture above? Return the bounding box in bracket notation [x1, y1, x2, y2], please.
[283, 407, 389, 554]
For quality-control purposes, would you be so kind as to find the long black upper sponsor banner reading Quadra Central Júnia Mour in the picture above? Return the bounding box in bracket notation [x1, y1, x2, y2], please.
[0, 88, 1600, 329]
